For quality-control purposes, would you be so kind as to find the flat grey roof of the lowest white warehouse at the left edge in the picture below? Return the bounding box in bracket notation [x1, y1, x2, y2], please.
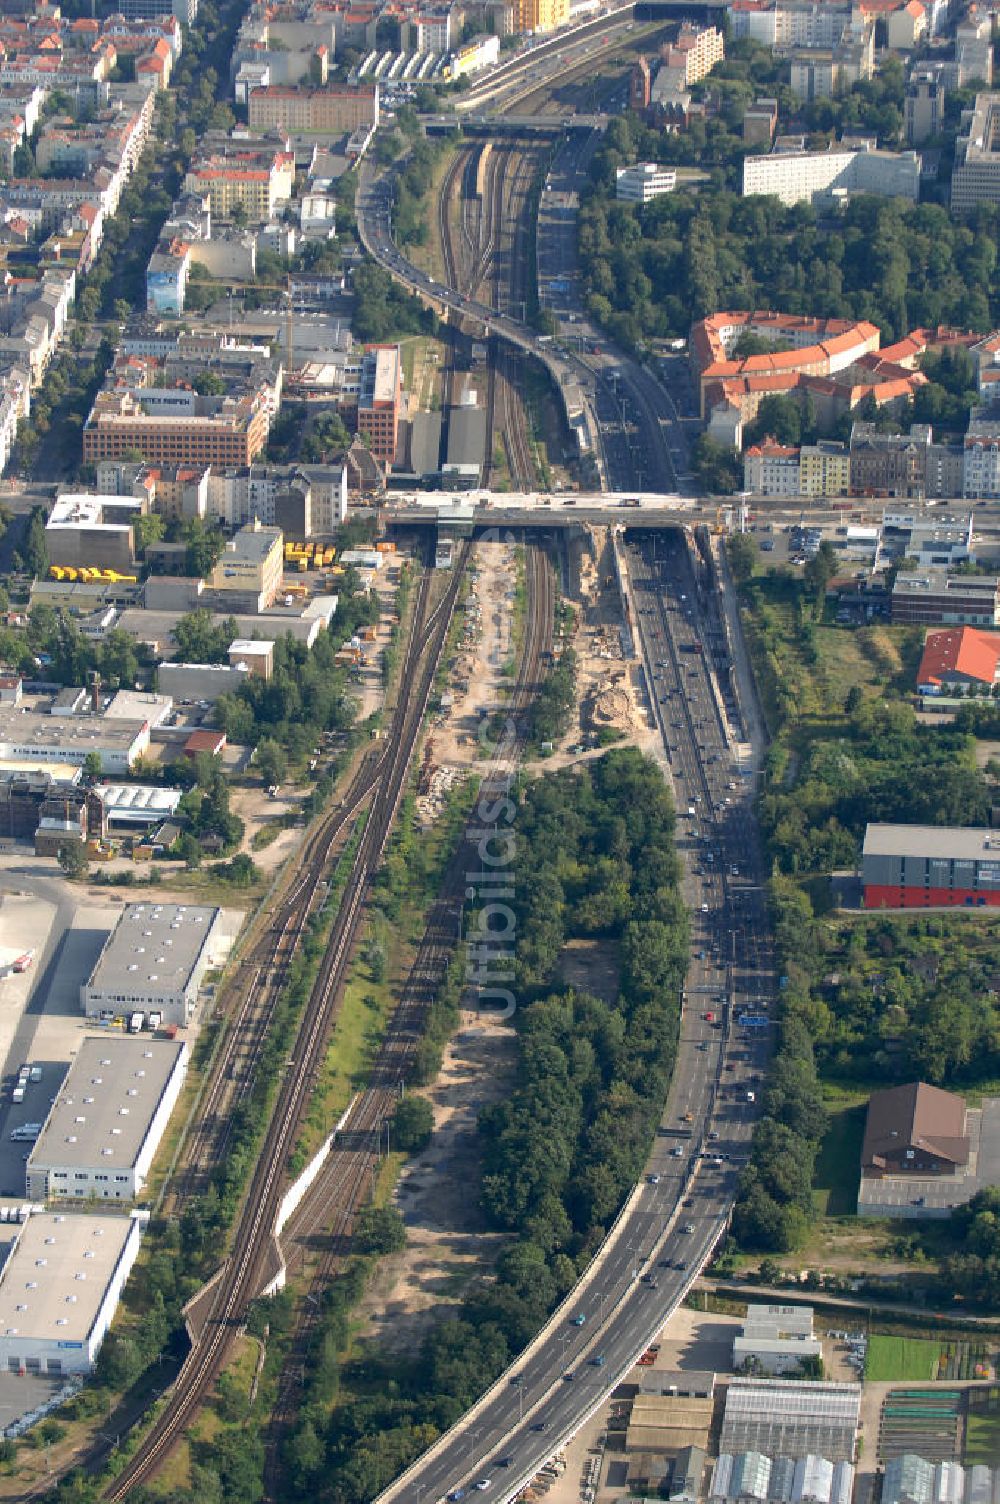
[0, 1212, 134, 1342]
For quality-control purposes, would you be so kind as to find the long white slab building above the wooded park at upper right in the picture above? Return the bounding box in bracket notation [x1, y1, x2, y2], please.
[743, 149, 920, 205]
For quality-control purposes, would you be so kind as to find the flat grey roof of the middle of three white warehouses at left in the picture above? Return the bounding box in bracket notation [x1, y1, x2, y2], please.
[27, 1033, 186, 1173]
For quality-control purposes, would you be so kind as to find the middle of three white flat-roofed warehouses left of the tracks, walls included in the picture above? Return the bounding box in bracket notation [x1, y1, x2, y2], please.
[26, 1033, 188, 1202]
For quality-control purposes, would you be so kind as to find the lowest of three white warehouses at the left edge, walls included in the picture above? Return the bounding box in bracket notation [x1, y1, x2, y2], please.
[0, 1212, 147, 1378]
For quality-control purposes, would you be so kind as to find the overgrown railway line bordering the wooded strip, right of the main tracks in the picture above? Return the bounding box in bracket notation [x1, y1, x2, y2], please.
[265, 541, 555, 1501]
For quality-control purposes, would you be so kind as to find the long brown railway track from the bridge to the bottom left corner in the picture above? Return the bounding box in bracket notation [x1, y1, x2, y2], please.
[104, 544, 469, 1501]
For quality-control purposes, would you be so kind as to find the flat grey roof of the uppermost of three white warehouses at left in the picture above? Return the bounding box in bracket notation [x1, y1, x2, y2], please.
[87, 904, 218, 996]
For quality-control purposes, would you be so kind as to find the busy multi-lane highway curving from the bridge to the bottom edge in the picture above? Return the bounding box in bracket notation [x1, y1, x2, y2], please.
[380, 531, 774, 1504]
